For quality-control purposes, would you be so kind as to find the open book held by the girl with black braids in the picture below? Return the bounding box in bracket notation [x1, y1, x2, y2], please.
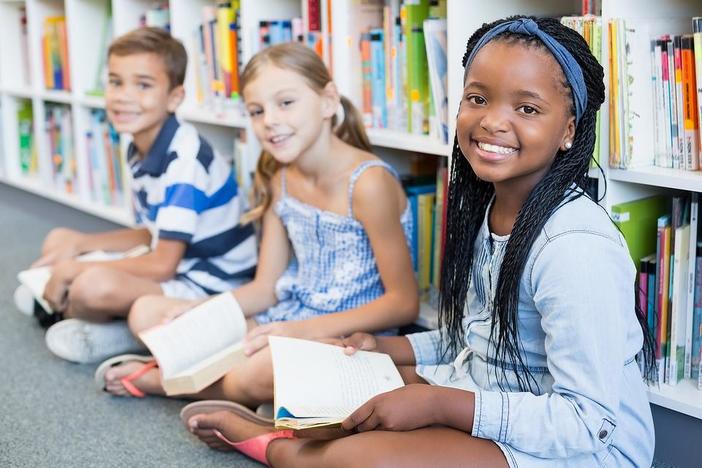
[269, 336, 404, 430]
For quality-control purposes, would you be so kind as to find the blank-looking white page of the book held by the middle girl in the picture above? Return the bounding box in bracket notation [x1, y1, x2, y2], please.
[139, 291, 246, 379]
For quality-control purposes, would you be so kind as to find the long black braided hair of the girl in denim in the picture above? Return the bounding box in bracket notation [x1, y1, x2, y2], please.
[439, 16, 655, 392]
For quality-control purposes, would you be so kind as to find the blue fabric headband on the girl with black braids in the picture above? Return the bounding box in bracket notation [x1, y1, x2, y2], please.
[466, 18, 587, 125]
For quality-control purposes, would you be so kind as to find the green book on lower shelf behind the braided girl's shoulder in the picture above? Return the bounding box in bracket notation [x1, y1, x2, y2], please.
[612, 195, 670, 268]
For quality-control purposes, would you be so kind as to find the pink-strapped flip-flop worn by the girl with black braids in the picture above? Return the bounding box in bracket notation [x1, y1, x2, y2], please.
[180, 400, 295, 466]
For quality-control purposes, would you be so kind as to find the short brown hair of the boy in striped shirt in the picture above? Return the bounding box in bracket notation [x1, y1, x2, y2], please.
[107, 27, 188, 89]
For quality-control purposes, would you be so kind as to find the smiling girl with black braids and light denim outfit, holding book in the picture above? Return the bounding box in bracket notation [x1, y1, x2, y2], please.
[180, 17, 654, 468]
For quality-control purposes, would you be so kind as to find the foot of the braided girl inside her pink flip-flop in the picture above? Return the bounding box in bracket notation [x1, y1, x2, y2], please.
[188, 411, 275, 452]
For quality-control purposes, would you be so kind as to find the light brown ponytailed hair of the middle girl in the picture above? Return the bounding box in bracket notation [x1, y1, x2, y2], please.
[241, 42, 371, 223]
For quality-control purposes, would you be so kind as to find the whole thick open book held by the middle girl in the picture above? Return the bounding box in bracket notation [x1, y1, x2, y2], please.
[139, 292, 246, 395]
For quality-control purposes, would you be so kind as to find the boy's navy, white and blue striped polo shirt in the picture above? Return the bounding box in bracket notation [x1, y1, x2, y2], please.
[128, 115, 256, 294]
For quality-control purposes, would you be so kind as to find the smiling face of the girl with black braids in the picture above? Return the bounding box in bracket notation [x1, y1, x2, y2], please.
[457, 40, 574, 187]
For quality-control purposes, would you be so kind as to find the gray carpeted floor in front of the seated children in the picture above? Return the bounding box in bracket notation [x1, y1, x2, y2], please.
[0, 184, 260, 467]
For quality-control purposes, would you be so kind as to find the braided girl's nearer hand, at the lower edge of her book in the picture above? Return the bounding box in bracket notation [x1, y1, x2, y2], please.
[341, 384, 437, 432]
